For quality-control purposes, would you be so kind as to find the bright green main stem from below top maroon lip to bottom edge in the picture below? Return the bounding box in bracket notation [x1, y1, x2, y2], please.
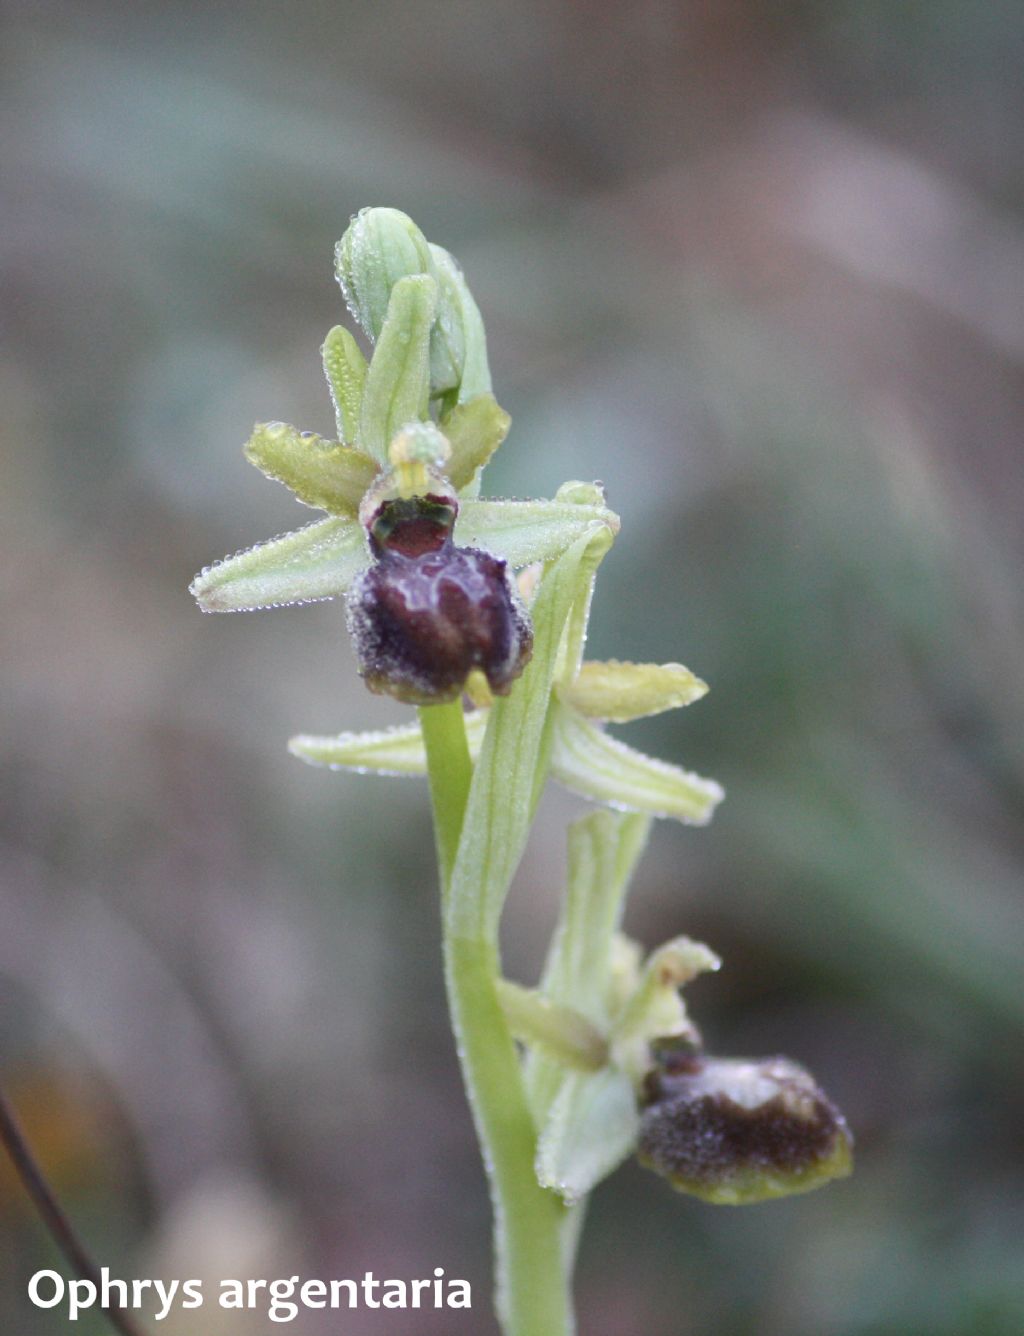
[421, 703, 575, 1336]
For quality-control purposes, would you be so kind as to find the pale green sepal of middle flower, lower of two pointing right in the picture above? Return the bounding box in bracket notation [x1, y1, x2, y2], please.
[551, 704, 725, 826]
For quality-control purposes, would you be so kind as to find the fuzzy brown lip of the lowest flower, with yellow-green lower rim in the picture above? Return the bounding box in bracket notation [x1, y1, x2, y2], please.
[638, 1050, 853, 1205]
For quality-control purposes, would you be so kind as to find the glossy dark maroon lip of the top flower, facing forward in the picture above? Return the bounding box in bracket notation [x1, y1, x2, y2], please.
[349, 497, 533, 705]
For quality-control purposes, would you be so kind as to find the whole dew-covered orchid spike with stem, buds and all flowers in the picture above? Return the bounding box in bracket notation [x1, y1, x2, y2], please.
[191, 208, 850, 1336]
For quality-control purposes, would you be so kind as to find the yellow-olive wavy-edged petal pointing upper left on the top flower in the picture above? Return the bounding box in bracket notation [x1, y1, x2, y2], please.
[245, 422, 377, 517]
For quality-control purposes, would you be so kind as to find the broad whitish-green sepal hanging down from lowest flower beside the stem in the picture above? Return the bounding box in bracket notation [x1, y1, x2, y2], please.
[536, 1067, 640, 1204]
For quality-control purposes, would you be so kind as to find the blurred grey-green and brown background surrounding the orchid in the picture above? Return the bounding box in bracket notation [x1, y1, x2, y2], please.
[0, 0, 1024, 1336]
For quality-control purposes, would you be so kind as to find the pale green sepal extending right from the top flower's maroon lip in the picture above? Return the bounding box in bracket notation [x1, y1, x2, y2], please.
[455, 501, 619, 569]
